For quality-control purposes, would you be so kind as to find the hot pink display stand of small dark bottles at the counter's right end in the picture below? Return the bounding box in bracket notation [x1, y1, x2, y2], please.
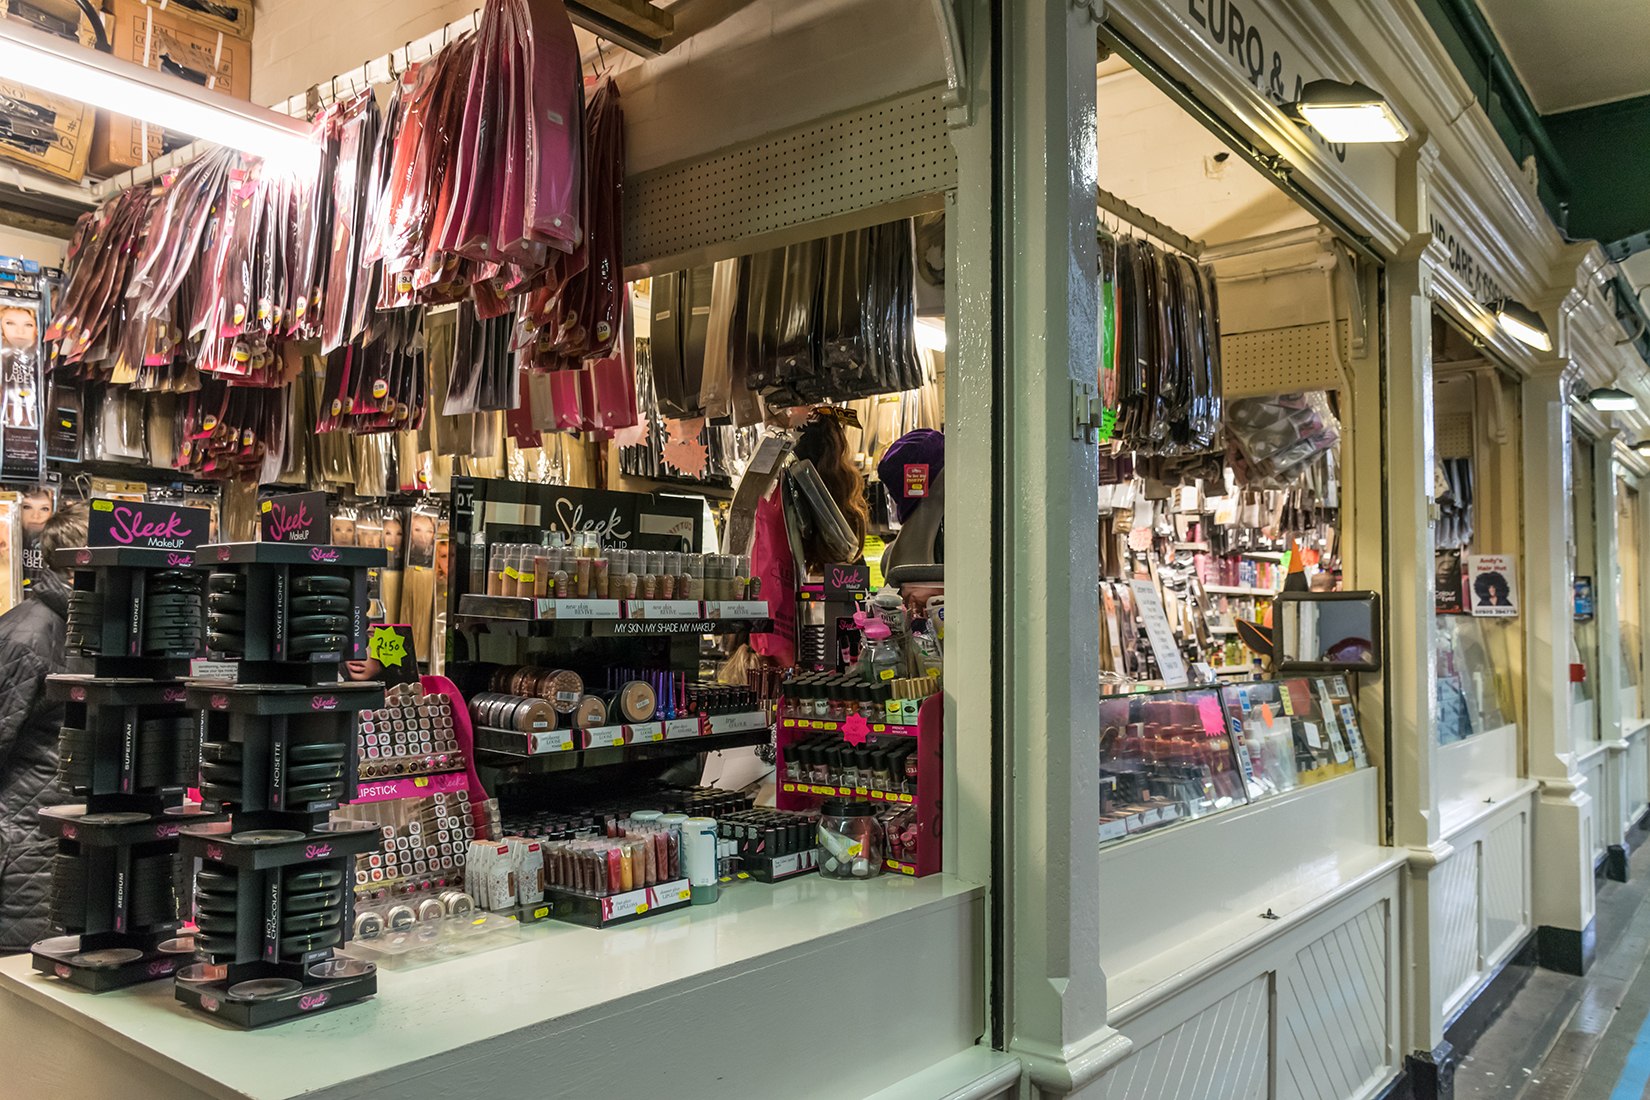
[776, 694, 944, 877]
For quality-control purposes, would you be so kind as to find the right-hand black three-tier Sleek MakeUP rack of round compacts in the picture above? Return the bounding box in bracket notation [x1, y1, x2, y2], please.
[175, 543, 384, 1027]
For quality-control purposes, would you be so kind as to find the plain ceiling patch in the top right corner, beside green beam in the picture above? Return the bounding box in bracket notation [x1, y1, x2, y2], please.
[1478, 0, 1650, 114]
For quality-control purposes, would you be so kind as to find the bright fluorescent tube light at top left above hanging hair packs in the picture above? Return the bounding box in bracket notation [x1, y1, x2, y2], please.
[0, 20, 310, 160]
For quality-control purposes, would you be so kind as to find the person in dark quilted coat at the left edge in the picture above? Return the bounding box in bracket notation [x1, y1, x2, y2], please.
[0, 505, 86, 952]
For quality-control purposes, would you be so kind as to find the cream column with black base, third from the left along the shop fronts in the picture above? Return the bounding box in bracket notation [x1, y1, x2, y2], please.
[1523, 360, 1594, 975]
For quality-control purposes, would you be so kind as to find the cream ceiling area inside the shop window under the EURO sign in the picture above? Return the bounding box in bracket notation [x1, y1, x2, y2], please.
[1096, 56, 1313, 246]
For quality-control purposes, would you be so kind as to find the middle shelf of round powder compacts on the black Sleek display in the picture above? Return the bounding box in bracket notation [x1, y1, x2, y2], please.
[470, 665, 772, 755]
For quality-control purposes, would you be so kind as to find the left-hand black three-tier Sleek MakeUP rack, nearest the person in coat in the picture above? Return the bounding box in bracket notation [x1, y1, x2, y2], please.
[30, 548, 227, 993]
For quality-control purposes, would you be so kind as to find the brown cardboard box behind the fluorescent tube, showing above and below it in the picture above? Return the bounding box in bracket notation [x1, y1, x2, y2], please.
[89, 0, 252, 176]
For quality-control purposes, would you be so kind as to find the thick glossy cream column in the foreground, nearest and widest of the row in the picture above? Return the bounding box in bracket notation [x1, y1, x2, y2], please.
[988, 0, 1129, 1100]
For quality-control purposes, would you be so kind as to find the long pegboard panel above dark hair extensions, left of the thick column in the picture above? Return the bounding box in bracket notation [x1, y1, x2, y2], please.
[624, 86, 957, 277]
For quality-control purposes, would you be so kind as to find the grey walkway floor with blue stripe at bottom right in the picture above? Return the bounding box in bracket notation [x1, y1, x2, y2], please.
[1455, 844, 1650, 1100]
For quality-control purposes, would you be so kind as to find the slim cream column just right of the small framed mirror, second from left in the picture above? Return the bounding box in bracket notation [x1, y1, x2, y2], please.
[1381, 142, 1454, 1097]
